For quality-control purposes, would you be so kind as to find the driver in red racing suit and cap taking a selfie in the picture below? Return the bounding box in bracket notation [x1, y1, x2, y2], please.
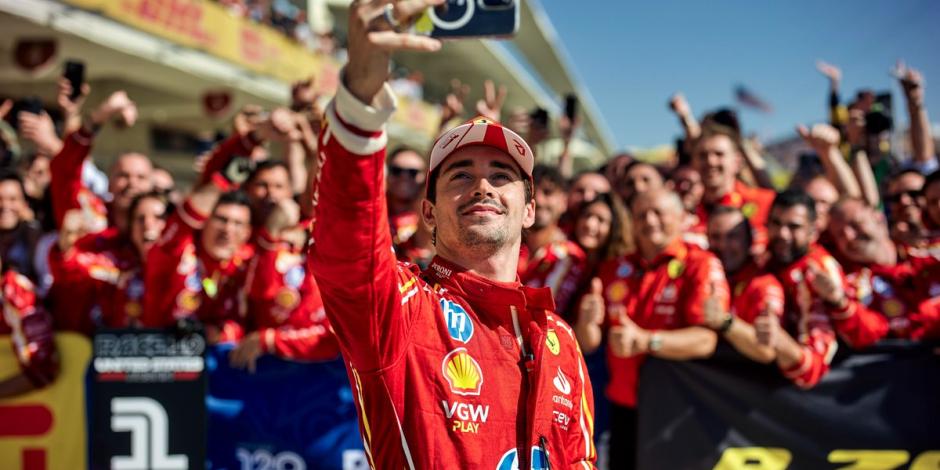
[308, 0, 594, 469]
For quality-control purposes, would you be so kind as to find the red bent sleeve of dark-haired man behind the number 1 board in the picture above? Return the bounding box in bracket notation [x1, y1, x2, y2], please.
[141, 202, 208, 328]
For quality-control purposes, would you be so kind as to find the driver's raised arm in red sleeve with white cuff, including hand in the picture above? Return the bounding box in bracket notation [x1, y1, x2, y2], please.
[308, 0, 440, 370]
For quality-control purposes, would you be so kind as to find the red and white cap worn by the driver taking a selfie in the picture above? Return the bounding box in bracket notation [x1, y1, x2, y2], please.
[428, 116, 535, 185]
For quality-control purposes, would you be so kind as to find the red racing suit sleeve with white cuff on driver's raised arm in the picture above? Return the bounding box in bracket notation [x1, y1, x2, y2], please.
[308, 74, 408, 371]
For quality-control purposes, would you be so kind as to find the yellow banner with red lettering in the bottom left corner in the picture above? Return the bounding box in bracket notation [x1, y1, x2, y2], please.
[0, 333, 91, 470]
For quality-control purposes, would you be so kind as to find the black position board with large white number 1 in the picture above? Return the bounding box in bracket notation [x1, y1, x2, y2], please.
[88, 330, 206, 470]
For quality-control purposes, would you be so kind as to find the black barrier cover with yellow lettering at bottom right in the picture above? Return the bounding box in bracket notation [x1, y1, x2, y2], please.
[637, 343, 940, 470]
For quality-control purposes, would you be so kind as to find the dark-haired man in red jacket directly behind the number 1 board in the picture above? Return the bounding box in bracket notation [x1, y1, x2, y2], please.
[142, 183, 254, 342]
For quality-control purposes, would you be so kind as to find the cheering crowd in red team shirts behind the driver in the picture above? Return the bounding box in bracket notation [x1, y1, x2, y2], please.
[0, 44, 940, 468]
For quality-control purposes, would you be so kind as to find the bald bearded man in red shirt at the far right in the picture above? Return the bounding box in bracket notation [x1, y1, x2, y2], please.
[829, 199, 937, 348]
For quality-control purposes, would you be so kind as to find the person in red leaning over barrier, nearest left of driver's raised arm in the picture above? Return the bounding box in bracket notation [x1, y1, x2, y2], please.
[229, 199, 339, 371]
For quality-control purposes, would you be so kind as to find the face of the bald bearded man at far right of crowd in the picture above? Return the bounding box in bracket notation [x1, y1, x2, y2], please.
[829, 201, 888, 264]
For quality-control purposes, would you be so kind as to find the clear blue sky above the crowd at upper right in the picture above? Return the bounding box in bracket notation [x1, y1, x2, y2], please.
[541, 0, 940, 148]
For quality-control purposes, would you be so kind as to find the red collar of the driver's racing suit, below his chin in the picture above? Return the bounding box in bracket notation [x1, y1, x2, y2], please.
[424, 256, 555, 315]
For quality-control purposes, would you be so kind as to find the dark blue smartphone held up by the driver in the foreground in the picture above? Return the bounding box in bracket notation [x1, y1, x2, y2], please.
[412, 0, 520, 39]
